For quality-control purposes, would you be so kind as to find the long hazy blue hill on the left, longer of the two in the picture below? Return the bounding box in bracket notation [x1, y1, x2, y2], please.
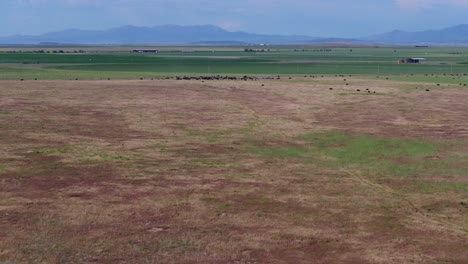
[0, 25, 316, 44]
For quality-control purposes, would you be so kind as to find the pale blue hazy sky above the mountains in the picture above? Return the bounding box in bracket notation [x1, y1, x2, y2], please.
[0, 0, 468, 37]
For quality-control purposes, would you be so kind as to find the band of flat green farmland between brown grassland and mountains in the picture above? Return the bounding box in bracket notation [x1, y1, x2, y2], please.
[0, 46, 468, 79]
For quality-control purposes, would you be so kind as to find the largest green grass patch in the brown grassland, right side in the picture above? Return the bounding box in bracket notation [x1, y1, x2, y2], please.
[249, 132, 468, 177]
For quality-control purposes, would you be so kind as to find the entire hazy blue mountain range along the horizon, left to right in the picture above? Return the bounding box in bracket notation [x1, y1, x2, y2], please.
[0, 25, 468, 45]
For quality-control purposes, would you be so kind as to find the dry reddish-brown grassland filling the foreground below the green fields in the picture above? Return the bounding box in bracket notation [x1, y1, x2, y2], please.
[0, 76, 468, 263]
